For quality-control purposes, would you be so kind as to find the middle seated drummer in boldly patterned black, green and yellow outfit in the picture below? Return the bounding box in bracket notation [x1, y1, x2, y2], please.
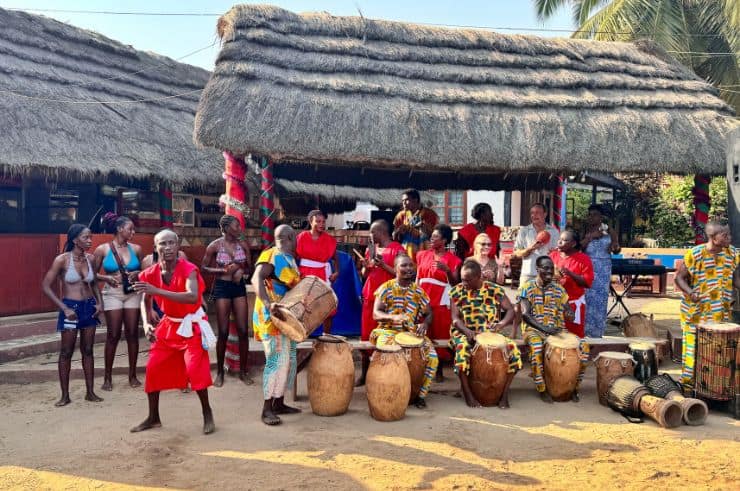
[450, 259, 522, 409]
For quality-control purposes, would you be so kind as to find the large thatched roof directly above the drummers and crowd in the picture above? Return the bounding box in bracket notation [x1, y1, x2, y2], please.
[194, 5, 737, 188]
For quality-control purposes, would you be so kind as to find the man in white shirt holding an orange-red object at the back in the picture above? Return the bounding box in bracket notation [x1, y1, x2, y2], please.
[514, 203, 559, 286]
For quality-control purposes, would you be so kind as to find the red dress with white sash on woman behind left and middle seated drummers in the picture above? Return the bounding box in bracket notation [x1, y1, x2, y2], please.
[416, 250, 462, 360]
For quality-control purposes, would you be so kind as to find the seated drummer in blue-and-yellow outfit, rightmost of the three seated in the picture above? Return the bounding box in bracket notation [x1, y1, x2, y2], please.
[517, 256, 589, 404]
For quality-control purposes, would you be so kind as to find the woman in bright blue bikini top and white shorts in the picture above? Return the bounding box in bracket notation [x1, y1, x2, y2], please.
[93, 213, 142, 390]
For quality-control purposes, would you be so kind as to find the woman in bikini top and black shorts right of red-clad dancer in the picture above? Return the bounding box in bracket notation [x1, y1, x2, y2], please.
[201, 215, 254, 387]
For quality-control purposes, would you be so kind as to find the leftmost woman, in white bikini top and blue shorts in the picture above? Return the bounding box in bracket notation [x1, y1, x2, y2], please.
[41, 223, 103, 407]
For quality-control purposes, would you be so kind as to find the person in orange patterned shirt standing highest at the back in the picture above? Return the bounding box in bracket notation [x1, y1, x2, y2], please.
[393, 189, 439, 262]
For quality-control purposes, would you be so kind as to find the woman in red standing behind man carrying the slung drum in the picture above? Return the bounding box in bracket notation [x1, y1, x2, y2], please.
[295, 210, 339, 334]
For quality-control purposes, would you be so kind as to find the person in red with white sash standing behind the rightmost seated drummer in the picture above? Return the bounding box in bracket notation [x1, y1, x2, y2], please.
[550, 230, 594, 338]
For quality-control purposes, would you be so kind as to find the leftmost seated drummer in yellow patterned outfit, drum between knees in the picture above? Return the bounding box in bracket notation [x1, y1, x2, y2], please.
[370, 254, 439, 409]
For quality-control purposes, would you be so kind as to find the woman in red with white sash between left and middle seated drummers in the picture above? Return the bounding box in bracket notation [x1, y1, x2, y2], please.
[416, 224, 462, 380]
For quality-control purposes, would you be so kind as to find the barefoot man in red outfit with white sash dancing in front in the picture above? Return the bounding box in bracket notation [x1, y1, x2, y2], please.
[131, 230, 216, 434]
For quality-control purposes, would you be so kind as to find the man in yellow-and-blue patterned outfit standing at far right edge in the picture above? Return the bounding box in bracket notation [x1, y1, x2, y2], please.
[676, 221, 740, 393]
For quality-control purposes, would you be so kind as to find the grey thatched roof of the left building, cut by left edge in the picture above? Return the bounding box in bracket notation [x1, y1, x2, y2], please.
[0, 9, 223, 185]
